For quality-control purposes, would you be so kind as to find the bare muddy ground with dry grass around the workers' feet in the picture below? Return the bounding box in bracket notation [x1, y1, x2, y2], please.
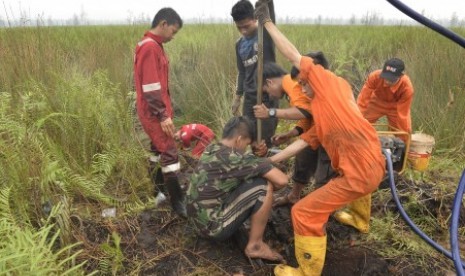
[76, 165, 463, 276]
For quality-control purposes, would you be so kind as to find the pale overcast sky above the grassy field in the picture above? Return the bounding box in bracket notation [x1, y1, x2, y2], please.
[0, 0, 465, 21]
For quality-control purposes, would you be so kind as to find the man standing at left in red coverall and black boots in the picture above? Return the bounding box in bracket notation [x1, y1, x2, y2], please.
[134, 8, 186, 217]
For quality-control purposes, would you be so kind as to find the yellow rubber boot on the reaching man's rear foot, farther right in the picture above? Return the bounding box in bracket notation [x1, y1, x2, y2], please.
[334, 194, 371, 234]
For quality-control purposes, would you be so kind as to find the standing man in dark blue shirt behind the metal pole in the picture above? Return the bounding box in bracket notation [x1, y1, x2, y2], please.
[231, 0, 279, 147]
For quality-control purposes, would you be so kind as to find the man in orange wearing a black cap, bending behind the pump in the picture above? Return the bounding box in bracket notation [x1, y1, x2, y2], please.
[357, 58, 413, 141]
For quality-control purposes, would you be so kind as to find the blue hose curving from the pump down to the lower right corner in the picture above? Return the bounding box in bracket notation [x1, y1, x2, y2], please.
[382, 149, 465, 267]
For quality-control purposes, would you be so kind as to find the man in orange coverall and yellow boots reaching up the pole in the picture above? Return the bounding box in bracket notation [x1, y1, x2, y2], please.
[255, 0, 385, 276]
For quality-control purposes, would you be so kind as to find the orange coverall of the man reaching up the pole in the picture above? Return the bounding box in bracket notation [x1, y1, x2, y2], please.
[298, 57, 385, 237]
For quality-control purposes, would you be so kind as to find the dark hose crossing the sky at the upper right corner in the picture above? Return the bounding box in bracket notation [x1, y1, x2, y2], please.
[386, 0, 465, 48]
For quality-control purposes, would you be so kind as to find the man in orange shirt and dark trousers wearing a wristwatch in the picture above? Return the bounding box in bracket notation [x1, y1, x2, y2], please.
[254, 62, 334, 206]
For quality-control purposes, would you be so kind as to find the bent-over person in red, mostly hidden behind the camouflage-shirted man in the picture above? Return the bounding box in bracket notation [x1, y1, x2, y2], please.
[175, 124, 215, 159]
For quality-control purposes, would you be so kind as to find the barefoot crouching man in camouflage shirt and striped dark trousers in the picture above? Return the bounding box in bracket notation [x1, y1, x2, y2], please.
[187, 117, 288, 261]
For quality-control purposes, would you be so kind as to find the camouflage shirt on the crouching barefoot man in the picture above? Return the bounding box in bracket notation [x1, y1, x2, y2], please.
[187, 143, 273, 237]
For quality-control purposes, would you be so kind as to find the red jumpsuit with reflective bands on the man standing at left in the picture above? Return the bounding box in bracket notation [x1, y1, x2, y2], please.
[134, 32, 180, 173]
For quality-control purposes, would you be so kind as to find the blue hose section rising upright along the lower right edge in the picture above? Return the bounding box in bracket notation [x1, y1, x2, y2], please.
[450, 170, 465, 276]
